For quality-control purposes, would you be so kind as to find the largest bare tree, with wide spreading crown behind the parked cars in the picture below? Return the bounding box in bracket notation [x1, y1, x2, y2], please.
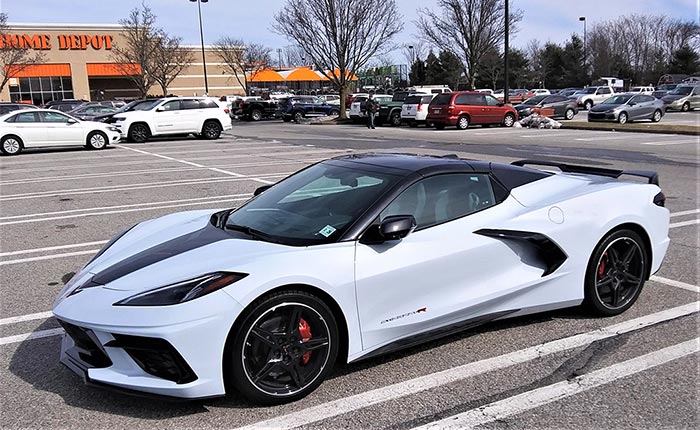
[273, 0, 403, 118]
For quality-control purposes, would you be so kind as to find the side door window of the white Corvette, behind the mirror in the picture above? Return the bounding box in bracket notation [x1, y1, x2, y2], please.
[379, 173, 496, 229]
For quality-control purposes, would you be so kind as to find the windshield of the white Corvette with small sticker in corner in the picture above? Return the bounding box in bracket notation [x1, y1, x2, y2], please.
[225, 162, 400, 246]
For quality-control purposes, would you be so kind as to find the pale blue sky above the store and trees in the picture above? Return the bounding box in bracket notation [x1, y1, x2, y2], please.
[0, 0, 700, 60]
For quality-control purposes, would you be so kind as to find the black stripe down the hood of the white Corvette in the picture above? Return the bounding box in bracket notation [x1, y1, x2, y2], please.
[91, 223, 232, 285]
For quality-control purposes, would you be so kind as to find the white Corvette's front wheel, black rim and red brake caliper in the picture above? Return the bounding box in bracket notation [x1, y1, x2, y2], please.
[224, 291, 340, 405]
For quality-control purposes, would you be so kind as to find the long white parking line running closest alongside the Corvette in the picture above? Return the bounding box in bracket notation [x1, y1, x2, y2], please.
[232, 302, 700, 430]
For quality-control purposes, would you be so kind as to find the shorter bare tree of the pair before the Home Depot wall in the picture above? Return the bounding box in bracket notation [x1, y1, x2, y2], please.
[149, 32, 192, 96]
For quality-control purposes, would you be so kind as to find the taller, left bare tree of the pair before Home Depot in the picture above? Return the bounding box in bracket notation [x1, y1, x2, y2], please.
[111, 4, 160, 97]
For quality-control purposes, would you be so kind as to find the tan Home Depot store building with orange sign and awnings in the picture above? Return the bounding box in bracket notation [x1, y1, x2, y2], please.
[0, 24, 243, 105]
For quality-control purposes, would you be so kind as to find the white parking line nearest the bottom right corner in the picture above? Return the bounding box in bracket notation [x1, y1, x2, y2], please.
[414, 338, 700, 430]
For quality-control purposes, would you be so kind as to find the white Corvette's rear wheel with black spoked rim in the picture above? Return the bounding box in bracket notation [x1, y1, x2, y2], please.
[584, 229, 649, 316]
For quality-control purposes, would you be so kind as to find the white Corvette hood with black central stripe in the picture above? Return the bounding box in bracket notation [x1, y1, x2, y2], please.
[76, 210, 295, 292]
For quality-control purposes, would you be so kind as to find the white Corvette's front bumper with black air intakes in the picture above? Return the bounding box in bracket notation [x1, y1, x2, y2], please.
[54, 288, 242, 399]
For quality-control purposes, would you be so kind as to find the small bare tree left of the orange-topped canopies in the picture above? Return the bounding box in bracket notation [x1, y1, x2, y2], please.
[214, 36, 271, 95]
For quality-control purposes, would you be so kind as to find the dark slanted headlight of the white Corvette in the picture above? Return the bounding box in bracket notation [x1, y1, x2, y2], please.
[114, 272, 248, 306]
